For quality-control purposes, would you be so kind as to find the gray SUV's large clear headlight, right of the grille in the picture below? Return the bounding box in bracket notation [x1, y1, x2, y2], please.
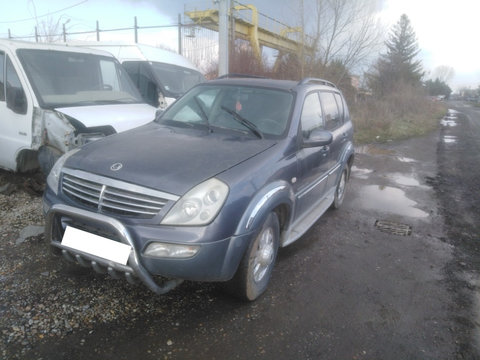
[162, 178, 228, 225]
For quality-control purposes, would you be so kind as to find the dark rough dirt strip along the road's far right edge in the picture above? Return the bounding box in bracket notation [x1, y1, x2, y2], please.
[432, 102, 480, 359]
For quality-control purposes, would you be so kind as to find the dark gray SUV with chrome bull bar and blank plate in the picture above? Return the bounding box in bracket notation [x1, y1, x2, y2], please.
[43, 77, 354, 300]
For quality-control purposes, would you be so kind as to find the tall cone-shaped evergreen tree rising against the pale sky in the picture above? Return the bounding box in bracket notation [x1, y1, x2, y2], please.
[369, 14, 424, 96]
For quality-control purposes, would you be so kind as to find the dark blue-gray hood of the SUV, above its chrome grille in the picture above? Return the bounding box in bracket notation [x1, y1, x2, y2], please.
[65, 122, 276, 196]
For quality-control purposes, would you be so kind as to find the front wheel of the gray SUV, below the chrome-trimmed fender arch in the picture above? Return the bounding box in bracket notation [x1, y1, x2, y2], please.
[227, 212, 280, 301]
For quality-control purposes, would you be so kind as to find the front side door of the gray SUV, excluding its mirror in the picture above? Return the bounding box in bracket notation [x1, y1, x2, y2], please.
[295, 91, 330, 219]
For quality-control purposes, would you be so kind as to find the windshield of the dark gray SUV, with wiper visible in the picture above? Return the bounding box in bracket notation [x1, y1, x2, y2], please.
[157, 85, 293, 138]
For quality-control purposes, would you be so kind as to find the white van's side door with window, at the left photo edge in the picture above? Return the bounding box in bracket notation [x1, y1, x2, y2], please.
[0, 49, 32, 170]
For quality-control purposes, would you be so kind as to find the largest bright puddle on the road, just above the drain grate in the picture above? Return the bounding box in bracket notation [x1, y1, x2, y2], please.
[358, 185, 428, 218]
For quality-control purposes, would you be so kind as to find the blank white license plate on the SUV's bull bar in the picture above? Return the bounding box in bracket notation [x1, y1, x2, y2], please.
[62, 226, 132, 265]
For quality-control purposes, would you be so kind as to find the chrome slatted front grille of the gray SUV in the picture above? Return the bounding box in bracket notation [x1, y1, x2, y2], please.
[62, 169, 177, 218]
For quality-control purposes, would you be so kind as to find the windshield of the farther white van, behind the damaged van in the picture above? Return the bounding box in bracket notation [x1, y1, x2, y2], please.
[152, 62, 205, 97]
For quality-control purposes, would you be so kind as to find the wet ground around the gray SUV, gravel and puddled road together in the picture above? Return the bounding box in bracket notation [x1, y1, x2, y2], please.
[0, 103, 480, 360]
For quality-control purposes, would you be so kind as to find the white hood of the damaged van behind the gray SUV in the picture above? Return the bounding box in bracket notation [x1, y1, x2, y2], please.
[55, 104, 156, 132]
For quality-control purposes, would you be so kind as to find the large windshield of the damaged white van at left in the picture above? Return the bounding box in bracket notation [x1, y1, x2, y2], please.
[18, 49, 143, 108]
